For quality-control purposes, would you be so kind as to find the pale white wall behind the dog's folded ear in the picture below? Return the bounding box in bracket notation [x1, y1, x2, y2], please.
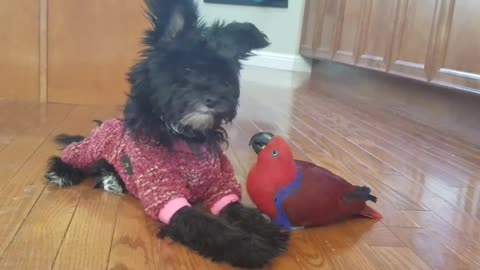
[197, 0, 305, 55]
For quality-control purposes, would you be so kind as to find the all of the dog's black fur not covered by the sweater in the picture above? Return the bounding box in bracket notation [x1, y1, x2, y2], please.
[47, 0, 289, 268]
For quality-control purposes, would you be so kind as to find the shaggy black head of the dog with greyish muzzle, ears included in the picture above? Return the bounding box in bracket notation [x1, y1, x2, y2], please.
[125, 0, 269, 148]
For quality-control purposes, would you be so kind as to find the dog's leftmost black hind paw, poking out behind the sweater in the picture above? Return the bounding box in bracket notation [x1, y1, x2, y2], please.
[45, 156, 86, 187]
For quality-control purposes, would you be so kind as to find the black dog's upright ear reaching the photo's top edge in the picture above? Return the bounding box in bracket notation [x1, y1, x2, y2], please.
[145, 0, 198, 45]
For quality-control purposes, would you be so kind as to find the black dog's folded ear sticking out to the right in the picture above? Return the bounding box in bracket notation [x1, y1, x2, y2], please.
[208, 22, 270, 60]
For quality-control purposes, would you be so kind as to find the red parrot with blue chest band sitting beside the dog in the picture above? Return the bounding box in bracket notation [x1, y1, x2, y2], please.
[247, 132, 382, 230]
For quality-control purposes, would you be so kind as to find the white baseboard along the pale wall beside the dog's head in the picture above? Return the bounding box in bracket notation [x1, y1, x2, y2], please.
[243, 51, 312, 72]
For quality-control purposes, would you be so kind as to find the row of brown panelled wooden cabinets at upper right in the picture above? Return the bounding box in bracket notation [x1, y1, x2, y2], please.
[300, 0, 480, 93]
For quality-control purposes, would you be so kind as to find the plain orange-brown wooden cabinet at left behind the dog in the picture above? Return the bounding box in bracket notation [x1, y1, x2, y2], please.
[0, 0, 150, 104]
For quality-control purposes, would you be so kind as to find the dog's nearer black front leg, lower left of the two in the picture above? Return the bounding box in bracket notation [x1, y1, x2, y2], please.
[159, 208, 285, 269]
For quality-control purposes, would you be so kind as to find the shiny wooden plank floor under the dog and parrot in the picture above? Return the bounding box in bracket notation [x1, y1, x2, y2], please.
[0, 66, 480, 270]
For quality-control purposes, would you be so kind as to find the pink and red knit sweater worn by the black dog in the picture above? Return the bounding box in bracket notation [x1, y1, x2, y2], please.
[62, 119, 241, 224]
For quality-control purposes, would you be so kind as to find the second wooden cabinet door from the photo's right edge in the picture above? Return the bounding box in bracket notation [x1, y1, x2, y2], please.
[389, 0, 441, 81]
